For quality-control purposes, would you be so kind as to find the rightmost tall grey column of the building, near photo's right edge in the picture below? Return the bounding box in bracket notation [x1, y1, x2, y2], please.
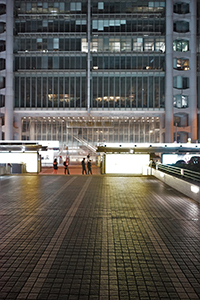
[189, 0, 197, 142]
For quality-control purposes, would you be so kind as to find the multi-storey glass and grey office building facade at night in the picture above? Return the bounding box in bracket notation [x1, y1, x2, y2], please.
[0, 0, 200, 147]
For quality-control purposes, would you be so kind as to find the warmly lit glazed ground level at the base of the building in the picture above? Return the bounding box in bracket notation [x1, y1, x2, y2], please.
[22, 117, 160, 147]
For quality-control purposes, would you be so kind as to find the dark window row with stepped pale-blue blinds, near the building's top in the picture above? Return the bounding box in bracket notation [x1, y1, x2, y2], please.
[15, 17, 165, 34]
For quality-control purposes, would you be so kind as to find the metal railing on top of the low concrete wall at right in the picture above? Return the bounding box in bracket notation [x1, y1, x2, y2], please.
[156, 164, 200, 182]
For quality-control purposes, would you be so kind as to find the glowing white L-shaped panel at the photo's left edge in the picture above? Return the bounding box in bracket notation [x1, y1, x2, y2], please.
[0, 152, 38, 173]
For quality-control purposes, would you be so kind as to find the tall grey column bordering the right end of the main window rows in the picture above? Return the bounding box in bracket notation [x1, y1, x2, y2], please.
[165, 0, 174, 143]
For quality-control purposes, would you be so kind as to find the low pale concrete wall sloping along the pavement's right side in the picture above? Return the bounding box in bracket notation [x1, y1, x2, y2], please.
[152, 168, 200, 203]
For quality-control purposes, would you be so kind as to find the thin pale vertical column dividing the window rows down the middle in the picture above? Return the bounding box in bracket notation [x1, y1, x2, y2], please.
[87, 0, 91, 113]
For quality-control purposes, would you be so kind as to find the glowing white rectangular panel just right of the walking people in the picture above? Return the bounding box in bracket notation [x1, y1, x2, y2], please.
[105, 154, 149, 174]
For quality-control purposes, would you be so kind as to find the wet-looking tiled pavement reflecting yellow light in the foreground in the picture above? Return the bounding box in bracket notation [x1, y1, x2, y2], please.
[0, 175, 200, 300]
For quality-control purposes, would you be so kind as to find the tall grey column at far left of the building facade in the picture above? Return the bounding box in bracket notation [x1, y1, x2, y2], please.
[5, 0, 14, 140]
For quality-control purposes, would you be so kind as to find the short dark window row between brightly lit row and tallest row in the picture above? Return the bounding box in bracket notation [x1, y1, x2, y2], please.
[14, 55, 165, 71]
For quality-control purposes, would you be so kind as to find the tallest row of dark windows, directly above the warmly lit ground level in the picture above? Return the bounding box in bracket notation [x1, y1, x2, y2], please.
[15, 76, 165, 108]
